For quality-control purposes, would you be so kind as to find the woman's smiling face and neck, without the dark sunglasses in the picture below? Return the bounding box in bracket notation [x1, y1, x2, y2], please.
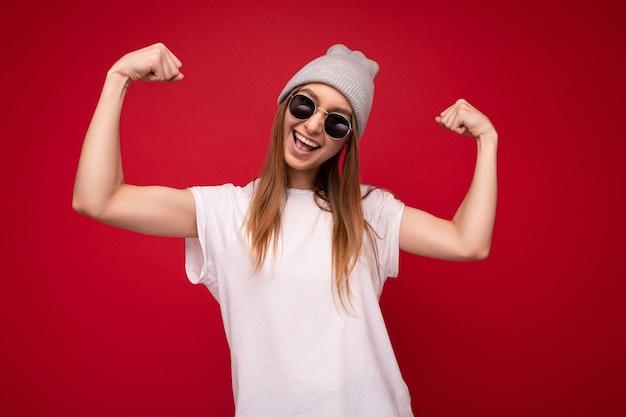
[284, 83, 353, 189]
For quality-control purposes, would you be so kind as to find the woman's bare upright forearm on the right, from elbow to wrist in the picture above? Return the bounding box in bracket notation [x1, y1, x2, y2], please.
[452, 130, 498, 259]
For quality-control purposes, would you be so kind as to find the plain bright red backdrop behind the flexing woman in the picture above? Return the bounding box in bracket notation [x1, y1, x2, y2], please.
[0, 0, 626, 417]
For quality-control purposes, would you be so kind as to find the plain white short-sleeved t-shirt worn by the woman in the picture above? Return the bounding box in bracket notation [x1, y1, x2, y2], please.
[186, 183, 413, 417]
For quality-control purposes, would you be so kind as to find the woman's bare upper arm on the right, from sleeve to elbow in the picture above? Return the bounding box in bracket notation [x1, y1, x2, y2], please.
[400, 206, 464, 260]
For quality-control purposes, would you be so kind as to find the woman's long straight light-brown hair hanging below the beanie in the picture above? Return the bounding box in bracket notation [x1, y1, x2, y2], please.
[245, 92, 378, 307]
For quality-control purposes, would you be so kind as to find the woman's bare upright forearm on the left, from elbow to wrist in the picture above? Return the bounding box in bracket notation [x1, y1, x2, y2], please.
[72, 71, 128, 217]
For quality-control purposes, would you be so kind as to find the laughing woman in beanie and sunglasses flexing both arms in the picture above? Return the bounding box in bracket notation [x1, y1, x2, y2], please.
[73, 44, 498, 417]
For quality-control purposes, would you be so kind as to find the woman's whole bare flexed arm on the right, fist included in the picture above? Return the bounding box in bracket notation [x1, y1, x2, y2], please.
[400, 99, 498, 261]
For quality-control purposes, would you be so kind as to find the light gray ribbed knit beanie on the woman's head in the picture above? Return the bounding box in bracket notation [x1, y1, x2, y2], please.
[278, 44, 379, 139]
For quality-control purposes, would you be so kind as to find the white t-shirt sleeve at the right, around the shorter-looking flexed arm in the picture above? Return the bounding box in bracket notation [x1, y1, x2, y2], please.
[363, 188, 404, 278]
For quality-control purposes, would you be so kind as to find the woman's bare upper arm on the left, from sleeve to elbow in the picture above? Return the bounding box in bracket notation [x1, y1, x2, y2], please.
[99, 184, 198, 237]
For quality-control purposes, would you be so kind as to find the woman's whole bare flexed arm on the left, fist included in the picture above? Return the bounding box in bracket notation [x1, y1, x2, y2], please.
[72, 44, 197, 237]
